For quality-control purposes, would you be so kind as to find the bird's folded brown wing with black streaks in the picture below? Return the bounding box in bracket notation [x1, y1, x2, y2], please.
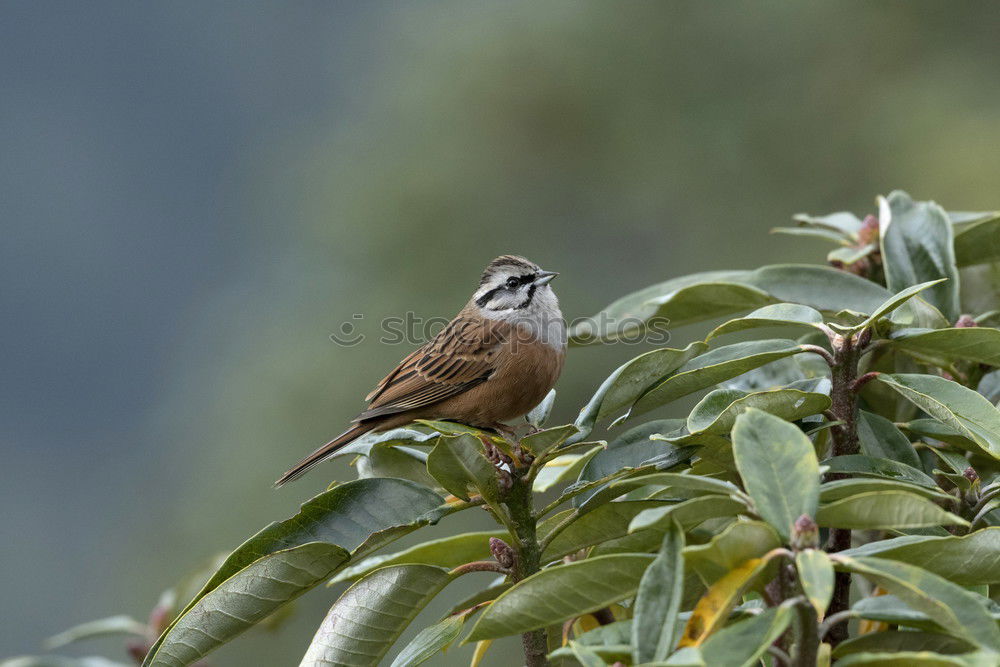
[354, 314, 506, 421]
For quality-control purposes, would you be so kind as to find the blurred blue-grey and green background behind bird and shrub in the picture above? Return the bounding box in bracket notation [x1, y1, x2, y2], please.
[0, 0, 1000, 666]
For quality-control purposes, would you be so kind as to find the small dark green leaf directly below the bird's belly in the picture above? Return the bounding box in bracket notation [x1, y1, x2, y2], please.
[427, 434, 500, 502]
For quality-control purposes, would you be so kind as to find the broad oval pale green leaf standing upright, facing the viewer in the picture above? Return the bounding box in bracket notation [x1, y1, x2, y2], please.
[733, 409, 819, 541]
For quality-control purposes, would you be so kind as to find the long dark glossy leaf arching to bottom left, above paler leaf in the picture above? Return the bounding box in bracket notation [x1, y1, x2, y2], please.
[143, 478, 444, 667]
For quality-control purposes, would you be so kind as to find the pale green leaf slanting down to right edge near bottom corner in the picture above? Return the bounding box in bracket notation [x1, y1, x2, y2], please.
[836, 555, 1000, 649]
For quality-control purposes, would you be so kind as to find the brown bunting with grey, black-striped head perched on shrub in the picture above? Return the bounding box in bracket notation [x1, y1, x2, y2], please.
[275, 255, 566, 487]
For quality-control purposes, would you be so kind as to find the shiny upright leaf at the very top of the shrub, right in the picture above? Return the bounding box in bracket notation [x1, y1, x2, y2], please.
[878, 190, 959, 322]
